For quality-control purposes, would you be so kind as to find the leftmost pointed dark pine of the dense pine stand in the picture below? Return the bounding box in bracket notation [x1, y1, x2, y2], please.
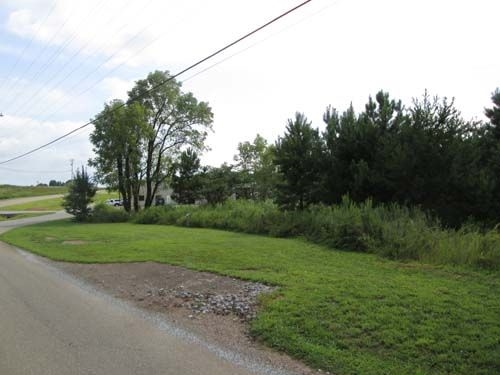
[274, 112, 324, 209]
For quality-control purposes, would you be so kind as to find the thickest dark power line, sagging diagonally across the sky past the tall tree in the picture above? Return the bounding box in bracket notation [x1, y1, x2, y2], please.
[0, 0, 312, 165]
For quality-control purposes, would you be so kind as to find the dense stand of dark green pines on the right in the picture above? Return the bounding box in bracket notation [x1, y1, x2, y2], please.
[274, 90, 500, 226]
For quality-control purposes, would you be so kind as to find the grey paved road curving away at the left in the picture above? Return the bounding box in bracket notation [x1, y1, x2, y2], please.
[0, 213, 278, 375]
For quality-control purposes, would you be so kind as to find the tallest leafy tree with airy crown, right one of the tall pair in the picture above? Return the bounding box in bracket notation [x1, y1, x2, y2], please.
[129, 71, 213, 207]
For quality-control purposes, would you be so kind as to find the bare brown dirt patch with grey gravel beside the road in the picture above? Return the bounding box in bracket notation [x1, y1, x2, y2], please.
[53, 262, 325, 375]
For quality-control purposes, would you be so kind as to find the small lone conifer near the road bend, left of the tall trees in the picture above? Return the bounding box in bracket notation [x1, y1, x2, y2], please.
[63, 167, 97, 221]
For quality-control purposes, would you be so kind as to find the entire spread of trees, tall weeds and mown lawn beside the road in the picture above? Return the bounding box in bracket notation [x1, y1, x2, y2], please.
[3, 75, 500, 374]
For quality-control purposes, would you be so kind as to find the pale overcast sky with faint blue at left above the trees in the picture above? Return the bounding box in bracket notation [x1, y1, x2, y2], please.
[0, 0, 500, 185]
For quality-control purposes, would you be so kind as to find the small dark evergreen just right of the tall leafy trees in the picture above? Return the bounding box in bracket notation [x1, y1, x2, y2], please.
[171, 148, 202, 204]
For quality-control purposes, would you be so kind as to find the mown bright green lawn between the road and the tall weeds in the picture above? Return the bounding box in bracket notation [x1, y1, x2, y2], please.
[2, 221, 500, 374]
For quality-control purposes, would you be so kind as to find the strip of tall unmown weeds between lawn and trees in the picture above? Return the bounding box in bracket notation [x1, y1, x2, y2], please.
[134, 197, 500, 269]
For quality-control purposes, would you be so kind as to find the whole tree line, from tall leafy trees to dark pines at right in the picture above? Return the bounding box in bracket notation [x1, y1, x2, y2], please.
[90, 75, 500, 227]
